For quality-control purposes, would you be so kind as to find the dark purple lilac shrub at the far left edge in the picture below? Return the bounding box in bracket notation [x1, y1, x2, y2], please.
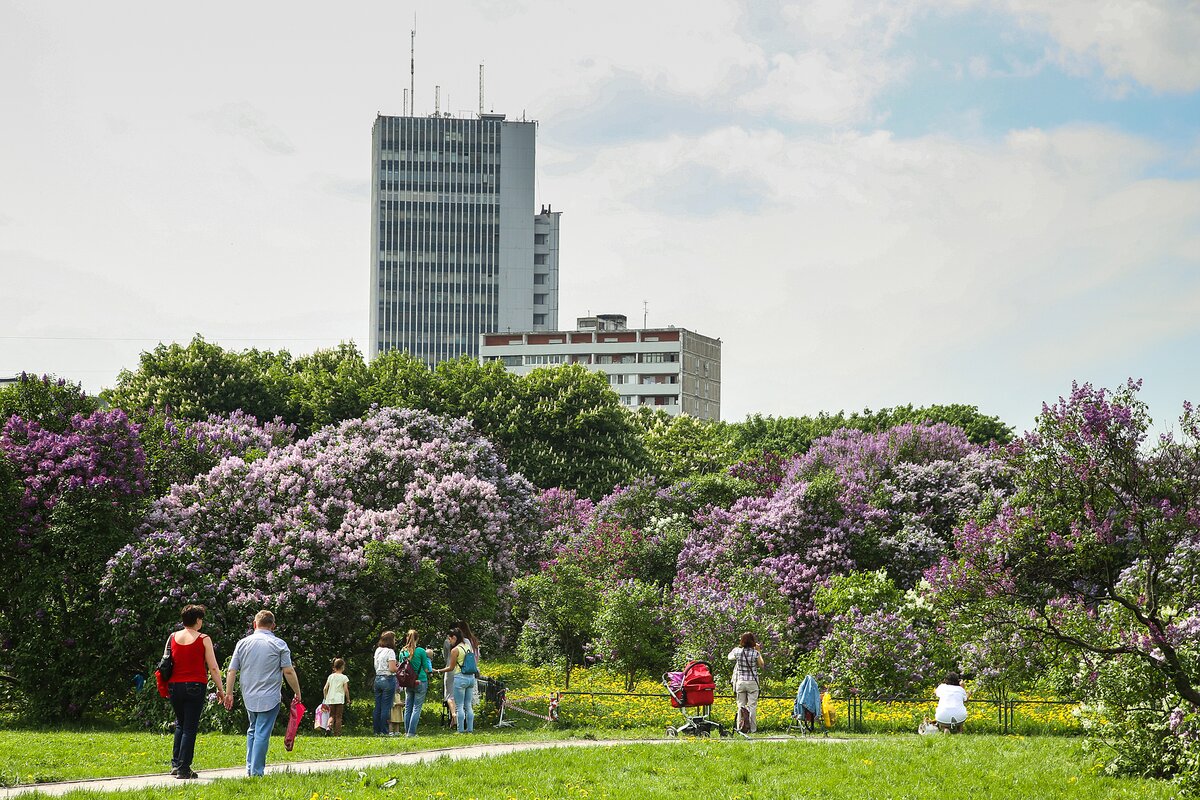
[0, 410, 148, 717]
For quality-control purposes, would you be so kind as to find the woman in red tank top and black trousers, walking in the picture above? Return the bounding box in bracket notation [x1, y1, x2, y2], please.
[167, 606, 224, 778]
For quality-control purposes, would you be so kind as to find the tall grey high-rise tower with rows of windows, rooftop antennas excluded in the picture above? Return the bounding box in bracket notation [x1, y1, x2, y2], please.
[370, 114, 559, 366]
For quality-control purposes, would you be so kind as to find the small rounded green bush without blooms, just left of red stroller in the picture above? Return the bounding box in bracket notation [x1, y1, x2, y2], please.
[595, 579, 673, 692]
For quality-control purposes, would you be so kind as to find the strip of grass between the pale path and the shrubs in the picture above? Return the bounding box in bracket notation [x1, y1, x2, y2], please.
[0, 724, 662, 786]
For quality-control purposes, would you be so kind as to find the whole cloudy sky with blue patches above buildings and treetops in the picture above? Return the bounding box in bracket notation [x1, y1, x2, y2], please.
[0, 0, 1200, 431]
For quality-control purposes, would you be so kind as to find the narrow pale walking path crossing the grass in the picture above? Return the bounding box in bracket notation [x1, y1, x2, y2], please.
[0, 736, 842, 800]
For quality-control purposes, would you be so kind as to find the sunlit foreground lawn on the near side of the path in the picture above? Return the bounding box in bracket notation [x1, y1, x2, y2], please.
[35, 735, 1175, 800]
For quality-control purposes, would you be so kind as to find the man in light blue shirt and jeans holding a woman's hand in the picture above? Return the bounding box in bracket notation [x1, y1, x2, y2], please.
[224, 610, 300, 776]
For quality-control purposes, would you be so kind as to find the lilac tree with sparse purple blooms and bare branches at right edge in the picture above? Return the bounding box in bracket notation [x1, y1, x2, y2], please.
[928, 381, 1200, 796]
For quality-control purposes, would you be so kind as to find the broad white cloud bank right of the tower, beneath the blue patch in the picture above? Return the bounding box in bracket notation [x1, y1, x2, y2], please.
[548, 127, 1200, 416]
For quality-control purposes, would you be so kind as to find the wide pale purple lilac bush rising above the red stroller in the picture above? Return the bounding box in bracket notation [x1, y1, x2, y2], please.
[676, 423, 1010, 662]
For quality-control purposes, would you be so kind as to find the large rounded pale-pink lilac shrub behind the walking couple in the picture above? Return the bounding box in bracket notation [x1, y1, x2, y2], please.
[104, 409, 538, 695]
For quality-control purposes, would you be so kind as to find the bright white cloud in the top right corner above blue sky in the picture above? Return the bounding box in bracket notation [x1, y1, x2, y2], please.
[1000, 0, 1200, 92]
